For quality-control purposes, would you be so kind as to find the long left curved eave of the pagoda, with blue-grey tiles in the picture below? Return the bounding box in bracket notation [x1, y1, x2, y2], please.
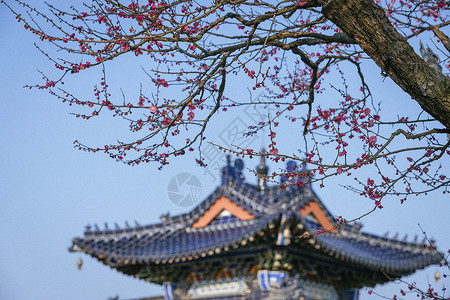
[71, 214, 279, 265]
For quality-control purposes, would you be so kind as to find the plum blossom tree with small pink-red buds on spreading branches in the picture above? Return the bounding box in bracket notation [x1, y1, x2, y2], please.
[2, 0, 450, 216]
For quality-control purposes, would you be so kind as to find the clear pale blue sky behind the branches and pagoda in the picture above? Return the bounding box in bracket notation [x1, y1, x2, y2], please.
[0, 5, 450, 300]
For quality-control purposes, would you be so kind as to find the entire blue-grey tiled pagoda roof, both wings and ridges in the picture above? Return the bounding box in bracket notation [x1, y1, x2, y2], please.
[70, 158, 440, 276]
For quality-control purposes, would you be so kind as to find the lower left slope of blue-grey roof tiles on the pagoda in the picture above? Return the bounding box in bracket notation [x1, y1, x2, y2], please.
[73, 214, 278, 263]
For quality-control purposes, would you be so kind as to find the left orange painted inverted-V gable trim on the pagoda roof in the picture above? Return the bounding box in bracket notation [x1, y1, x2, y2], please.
[192, 196, 255, 228]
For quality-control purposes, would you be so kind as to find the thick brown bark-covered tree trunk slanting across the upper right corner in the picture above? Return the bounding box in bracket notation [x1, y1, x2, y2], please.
[322, 0, 450, 129]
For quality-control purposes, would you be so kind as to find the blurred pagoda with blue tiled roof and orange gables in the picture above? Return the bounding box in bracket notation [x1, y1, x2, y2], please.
[70, 157, 441, 300]
